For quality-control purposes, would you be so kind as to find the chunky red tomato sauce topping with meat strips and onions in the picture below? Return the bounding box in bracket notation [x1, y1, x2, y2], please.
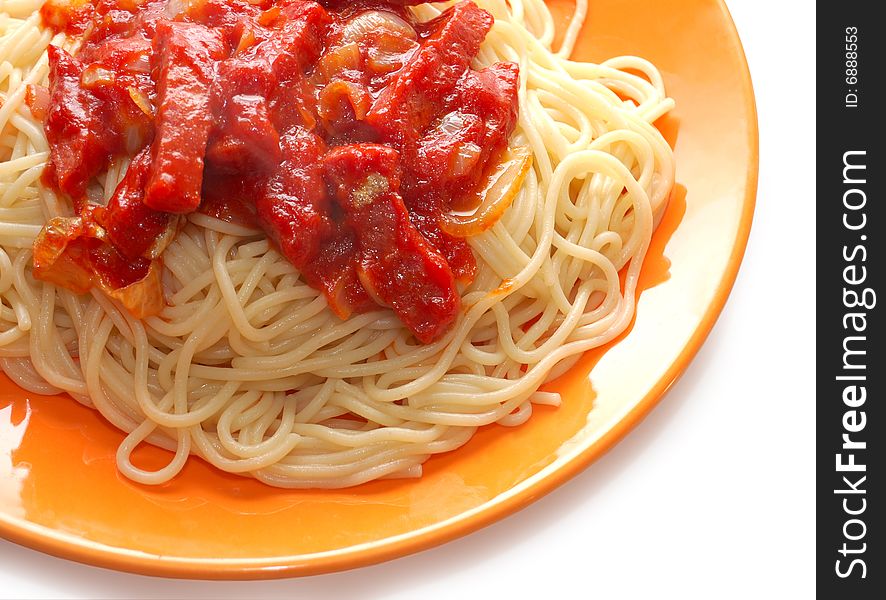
[34, 0, 519, 342]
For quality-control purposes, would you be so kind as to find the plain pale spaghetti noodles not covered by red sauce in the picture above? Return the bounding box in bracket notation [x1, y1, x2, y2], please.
[0, 0, 674, 488]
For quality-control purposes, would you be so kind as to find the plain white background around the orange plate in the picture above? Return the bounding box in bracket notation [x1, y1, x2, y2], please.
[0, 0, 815, 600]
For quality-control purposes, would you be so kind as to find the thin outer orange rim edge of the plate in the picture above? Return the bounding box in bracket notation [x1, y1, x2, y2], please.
[0, 0, 759, 580]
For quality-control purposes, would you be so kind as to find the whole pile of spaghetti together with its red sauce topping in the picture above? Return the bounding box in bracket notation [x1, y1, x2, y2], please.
[0, 0, 674, 488]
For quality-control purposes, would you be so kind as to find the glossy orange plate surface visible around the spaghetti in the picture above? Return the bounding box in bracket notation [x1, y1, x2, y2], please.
[0, 0, 757, 579]
